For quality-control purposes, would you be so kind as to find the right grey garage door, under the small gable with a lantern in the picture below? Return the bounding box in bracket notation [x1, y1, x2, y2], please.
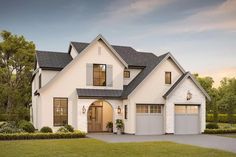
[175, 105, 200, 134]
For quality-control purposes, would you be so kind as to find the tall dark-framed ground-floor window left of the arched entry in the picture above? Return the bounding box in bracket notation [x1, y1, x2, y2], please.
[53, 98, 68, 126]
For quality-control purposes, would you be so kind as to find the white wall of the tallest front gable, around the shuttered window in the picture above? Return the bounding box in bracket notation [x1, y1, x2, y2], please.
[35, 41, 124, 131]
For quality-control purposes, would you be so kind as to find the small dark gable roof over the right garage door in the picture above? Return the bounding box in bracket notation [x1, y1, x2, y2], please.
[163, 72, 211, 101]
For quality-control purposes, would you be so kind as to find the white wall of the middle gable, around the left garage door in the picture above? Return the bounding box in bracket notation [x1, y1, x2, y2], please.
[125, 59, 182, 134]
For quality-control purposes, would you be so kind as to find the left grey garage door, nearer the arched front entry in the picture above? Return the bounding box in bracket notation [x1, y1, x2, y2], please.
[136, 104, 163, 135]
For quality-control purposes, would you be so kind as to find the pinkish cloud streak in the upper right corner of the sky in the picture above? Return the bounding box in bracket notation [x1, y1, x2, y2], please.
[156, 0, 236, 34]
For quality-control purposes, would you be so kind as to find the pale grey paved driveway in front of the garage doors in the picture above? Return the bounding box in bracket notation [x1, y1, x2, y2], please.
[87, 133, 236, 153]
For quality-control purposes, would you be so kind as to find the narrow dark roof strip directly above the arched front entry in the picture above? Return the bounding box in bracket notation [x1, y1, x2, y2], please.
[76, 88, 123, 99]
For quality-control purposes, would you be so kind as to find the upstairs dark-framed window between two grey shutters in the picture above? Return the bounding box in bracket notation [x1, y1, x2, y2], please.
[93, 64, 107, 86]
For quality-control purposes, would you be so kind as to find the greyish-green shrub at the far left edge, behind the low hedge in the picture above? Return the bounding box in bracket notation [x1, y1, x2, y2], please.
[0, 122, 24, 134]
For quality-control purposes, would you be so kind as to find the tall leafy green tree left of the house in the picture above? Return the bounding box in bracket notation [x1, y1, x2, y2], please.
[0, 31, 35, 119]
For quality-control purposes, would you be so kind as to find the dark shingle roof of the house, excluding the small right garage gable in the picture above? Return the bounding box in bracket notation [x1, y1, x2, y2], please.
[36, 42, 168, 98]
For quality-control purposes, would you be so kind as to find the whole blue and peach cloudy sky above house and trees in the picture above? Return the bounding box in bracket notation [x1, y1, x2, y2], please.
[0, 0, 236, 86]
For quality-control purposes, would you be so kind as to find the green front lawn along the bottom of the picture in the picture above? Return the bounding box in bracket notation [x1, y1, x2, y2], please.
[0, 138, 236, 157]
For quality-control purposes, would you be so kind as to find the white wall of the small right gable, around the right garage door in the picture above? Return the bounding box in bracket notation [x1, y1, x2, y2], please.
[165, 78, 206, 133]
